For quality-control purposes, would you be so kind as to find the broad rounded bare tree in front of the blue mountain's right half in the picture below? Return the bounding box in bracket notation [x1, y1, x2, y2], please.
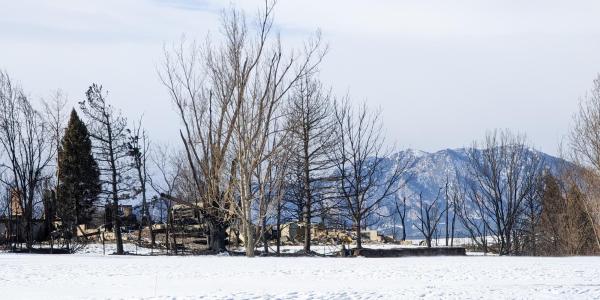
[468, 130, 543, 255]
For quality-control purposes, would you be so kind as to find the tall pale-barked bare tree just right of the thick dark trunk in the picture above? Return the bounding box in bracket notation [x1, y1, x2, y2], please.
[229, 5, 324, 256]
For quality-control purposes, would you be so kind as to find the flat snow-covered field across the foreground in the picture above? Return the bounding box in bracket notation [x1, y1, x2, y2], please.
[0, 245, 600, 299]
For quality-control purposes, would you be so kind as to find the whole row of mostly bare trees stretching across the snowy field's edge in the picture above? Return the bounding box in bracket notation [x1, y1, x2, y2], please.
[0, 2, 600, 256]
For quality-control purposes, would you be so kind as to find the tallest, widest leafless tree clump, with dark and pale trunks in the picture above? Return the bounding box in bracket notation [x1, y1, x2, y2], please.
[160, 2, 323, 256]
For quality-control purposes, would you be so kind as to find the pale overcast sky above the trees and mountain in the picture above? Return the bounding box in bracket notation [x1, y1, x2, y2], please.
[0, 0, 600, 153]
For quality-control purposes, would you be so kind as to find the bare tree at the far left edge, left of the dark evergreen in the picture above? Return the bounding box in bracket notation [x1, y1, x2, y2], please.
[0, 72, 54, 250]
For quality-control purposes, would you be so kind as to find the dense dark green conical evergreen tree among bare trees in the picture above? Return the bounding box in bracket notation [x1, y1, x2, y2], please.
[57, 109, 101, 238]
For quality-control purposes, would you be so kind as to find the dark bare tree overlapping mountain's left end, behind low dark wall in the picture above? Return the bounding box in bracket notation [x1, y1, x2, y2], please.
[332, 100, 408, 249]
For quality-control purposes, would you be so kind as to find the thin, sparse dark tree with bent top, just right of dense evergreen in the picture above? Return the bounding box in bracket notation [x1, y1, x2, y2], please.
[80, 84, 131, 255]
